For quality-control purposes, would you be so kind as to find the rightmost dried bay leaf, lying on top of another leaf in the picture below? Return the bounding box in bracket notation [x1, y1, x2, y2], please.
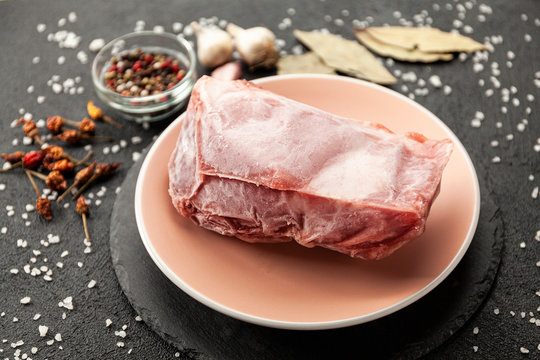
[365, 26, 486, 53]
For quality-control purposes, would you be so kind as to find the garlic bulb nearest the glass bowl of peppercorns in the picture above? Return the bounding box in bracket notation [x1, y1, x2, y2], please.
[190, 22, 233, 68]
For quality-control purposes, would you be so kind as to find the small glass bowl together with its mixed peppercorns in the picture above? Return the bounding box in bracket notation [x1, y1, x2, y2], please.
[92, 31, 197, 122]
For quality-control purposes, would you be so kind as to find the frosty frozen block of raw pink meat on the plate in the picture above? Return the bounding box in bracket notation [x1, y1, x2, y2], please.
[169, 76, 452, 259]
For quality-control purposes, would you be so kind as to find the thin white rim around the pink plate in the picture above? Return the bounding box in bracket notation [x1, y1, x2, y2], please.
[134, 74, 480, 330]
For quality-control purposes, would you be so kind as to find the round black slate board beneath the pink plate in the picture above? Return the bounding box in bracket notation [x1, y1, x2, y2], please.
[110, 148, 503, 360]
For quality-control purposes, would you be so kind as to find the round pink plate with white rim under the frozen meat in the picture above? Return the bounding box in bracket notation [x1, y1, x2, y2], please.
[135, 75, 480, 330]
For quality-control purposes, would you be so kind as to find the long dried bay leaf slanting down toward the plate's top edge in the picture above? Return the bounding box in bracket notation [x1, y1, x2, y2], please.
[294, 30, 397, 84]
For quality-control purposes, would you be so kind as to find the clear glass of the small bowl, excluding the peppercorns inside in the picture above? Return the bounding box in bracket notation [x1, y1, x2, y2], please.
[92, 31, 197, 122]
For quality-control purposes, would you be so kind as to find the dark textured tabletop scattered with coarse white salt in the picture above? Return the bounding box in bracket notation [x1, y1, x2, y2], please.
[0, 0, 540, 359]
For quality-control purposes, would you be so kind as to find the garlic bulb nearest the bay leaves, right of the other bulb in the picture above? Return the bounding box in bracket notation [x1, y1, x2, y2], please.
[227, 23, 279, 68]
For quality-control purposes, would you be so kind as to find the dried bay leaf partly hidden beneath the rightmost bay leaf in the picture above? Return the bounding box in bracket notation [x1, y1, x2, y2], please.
[354, 29, 454, 63]
